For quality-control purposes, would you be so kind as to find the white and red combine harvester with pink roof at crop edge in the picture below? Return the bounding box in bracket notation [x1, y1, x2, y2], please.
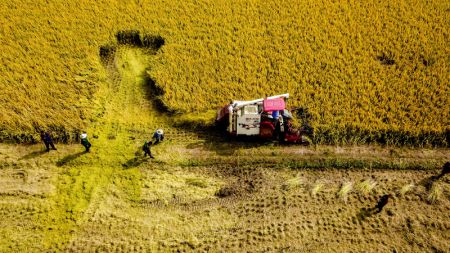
[216, 94, 308, 144]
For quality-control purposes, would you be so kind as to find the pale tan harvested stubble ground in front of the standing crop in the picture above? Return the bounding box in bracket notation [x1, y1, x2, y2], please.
[0, 143, 450, 252]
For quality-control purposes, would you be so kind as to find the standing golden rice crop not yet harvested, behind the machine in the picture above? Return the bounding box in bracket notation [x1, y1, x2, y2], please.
[0, 0, 450, 145]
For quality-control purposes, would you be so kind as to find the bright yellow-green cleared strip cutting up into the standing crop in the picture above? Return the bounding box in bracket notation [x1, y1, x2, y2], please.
[56, 47, 167, 249]
